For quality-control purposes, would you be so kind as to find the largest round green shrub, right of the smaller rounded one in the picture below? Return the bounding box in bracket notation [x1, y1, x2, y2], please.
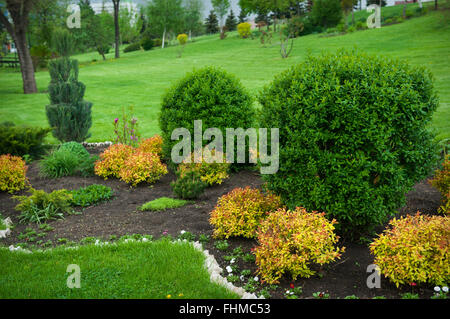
[259, 51, 438, 235]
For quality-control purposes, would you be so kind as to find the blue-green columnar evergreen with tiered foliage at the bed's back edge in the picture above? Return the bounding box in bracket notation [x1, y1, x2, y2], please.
[46, 57, 92, 143]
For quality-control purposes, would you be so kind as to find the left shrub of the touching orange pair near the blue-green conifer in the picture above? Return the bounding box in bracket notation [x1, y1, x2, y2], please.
[94, 144, 134, 179]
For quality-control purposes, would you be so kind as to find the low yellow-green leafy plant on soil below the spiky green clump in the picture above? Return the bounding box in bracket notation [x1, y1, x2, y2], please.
[13, 189, 73, 224]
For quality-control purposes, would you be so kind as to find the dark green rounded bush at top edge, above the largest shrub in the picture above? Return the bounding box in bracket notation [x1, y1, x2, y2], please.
[311, 0, 342, 28]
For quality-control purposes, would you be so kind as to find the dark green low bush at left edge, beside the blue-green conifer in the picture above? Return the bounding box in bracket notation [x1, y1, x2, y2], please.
[0, 122, 52, 159]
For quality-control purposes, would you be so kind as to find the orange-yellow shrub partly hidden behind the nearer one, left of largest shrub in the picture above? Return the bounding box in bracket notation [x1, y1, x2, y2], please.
[209, 186, 282, 238]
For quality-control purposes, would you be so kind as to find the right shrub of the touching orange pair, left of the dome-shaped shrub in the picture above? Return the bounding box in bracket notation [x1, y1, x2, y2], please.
[119, 150, 168, 186]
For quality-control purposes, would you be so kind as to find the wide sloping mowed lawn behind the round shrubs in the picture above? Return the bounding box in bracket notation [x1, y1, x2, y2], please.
[0, 8, 450, 142]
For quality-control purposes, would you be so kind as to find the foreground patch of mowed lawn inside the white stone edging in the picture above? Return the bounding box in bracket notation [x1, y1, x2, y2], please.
[0, 240, 239, 299]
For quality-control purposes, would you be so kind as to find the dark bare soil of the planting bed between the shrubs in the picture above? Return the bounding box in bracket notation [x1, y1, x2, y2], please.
[0, 150, 441, 298]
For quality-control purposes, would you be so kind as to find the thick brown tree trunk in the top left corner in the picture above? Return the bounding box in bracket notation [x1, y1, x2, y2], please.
[0, 0, 37, 94]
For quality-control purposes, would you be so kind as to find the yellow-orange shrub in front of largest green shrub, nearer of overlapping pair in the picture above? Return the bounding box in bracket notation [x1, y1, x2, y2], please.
[253, 207, 345, 284]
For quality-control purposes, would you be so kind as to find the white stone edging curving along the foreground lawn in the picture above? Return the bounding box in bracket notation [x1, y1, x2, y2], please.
[4, 238, 264, 299]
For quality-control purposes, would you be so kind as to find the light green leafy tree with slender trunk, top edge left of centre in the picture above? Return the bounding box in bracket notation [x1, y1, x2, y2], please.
[148, 0, 183, 48]
